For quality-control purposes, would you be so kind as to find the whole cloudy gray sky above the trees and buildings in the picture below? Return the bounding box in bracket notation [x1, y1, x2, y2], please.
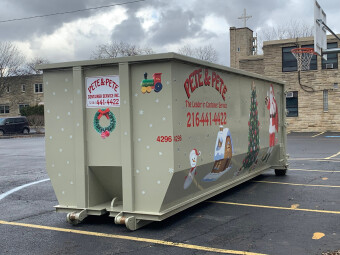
[0, 0, 340, 65]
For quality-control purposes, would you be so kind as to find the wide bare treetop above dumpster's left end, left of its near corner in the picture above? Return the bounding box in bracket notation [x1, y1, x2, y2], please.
[91, 41, 154, 59]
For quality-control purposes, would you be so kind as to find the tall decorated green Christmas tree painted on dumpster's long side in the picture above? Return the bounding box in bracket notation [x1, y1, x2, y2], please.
[240, 82, 260, 170]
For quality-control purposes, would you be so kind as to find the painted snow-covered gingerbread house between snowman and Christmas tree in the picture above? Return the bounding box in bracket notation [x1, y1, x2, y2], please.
[203, 126, 233, 182]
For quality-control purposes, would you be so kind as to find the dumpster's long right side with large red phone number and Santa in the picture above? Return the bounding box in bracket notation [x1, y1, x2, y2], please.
[162, 63, 285, 213]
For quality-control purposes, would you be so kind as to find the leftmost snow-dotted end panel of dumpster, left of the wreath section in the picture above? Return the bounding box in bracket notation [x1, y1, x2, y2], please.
[44, 70, 79, 206]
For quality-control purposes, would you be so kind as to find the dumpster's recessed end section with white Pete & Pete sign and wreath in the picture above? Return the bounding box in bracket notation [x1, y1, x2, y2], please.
[84, 65, 123, 209]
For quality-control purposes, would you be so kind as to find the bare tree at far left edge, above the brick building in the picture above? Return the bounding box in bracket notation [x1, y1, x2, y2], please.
[0, 42, 25, 96]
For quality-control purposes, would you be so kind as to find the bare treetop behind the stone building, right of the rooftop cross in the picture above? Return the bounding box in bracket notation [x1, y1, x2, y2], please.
[257, 20, 314, 53]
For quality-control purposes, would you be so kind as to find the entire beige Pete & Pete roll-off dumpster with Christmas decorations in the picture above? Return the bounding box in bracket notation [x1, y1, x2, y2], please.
[40, 53, 288, 230]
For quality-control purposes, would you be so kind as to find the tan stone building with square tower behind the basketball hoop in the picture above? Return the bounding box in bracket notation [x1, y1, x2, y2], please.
[230, 27, 340, 132]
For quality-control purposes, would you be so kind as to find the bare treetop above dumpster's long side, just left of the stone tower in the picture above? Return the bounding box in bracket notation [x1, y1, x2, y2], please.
[178, 44, 218, 63]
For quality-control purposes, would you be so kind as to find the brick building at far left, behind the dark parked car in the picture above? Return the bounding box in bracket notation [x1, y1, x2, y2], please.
[0, 75, 44, 117]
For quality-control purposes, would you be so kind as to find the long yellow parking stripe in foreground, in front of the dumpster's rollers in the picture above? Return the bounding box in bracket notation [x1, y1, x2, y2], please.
[0, 220, 265, 255]
